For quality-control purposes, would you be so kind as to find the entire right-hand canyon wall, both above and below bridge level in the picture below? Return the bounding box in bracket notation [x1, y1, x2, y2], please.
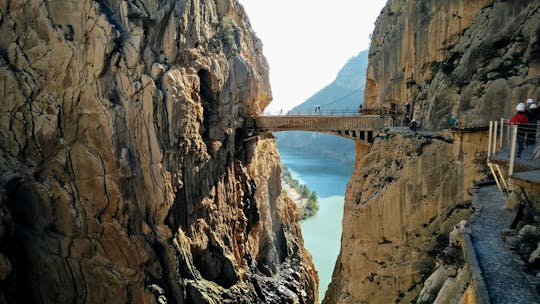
[323, 0, 540, 303]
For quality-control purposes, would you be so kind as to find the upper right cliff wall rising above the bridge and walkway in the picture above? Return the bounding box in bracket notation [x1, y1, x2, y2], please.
[365, 0, 540, 128]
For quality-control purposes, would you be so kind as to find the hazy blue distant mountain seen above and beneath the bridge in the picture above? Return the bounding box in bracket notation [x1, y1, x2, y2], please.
[275, 50, 368, 166]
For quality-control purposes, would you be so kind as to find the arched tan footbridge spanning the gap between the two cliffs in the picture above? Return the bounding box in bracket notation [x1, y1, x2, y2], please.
[246, 115, 389, 145]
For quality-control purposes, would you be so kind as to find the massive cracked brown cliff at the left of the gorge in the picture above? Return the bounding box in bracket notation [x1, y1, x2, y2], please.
[0, 0, 317, 303]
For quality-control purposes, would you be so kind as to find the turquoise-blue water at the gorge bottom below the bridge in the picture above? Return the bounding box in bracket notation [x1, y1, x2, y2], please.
[279, 147, 354, 301]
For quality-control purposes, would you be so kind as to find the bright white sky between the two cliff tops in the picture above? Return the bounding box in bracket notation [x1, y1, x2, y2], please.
[239, 0, 386, 112]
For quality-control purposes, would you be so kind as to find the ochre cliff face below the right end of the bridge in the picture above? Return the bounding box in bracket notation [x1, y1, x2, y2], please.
[323, 132, 487, 303]
